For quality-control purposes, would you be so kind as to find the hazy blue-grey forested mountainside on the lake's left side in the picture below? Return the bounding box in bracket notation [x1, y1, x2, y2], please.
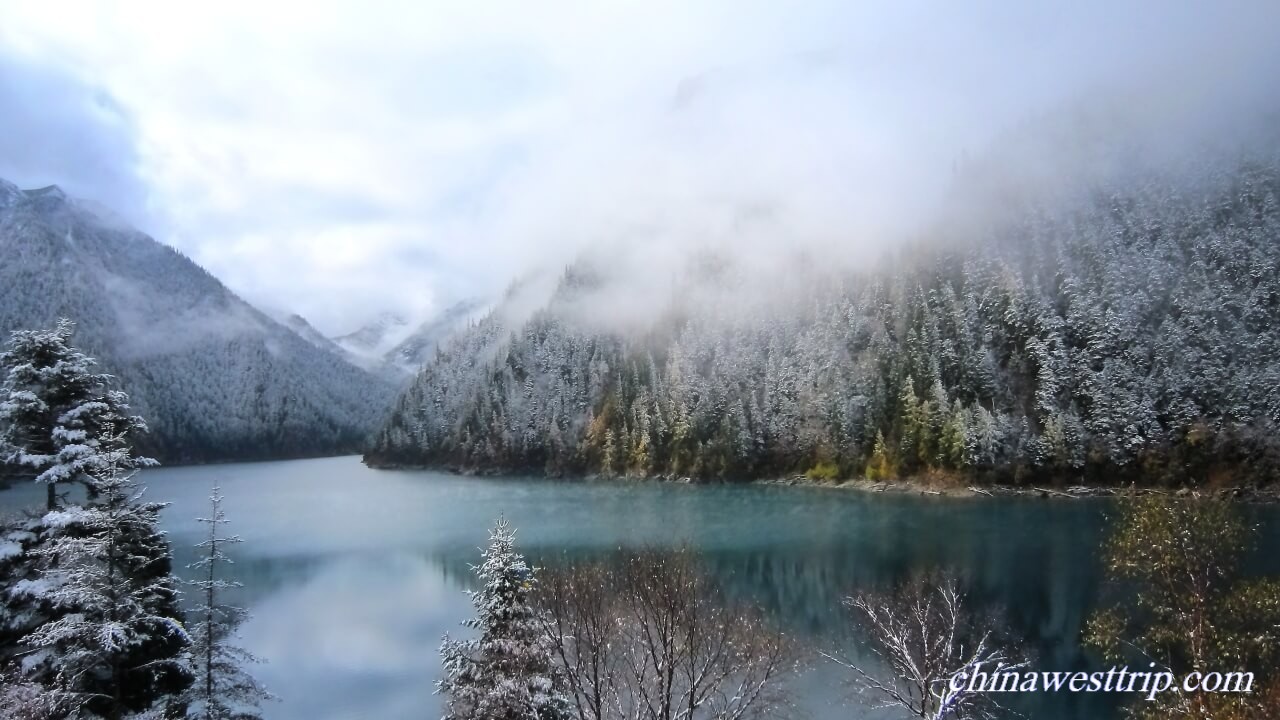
[0, 181, 396, 462]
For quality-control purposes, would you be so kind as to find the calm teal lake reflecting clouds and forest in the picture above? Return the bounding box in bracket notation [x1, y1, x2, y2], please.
[0, 457, 1280, 720]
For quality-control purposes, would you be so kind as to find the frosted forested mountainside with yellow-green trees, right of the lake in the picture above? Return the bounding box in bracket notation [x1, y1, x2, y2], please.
[366, 155, 1280, 483]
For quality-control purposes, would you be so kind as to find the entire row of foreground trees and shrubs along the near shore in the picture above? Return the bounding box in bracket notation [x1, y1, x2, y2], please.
[0, 323, 1280, 720]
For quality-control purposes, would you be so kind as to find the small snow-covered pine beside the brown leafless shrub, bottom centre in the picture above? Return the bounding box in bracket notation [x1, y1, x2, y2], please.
[436, 520, 568, 720]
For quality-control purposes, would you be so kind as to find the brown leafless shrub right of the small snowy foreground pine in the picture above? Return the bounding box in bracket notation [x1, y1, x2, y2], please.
[539, 548, 797, 720]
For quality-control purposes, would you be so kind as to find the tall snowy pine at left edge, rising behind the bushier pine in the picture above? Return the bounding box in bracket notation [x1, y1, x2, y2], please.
[0, 319, 155, 510]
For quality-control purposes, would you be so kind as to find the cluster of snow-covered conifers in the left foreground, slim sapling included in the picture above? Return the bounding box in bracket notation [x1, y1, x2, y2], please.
[0, 320, 270, 720]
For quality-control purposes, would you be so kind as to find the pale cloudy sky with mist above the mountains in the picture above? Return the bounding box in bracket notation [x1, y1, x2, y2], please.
[0, 0, 1280, 334]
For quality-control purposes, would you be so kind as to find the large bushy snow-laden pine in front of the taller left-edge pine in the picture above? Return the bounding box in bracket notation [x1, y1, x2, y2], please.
[12, 427, 192, 720]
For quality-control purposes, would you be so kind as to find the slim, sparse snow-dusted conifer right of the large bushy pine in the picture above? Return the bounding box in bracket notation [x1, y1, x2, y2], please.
[186, 486, 273, 720]
